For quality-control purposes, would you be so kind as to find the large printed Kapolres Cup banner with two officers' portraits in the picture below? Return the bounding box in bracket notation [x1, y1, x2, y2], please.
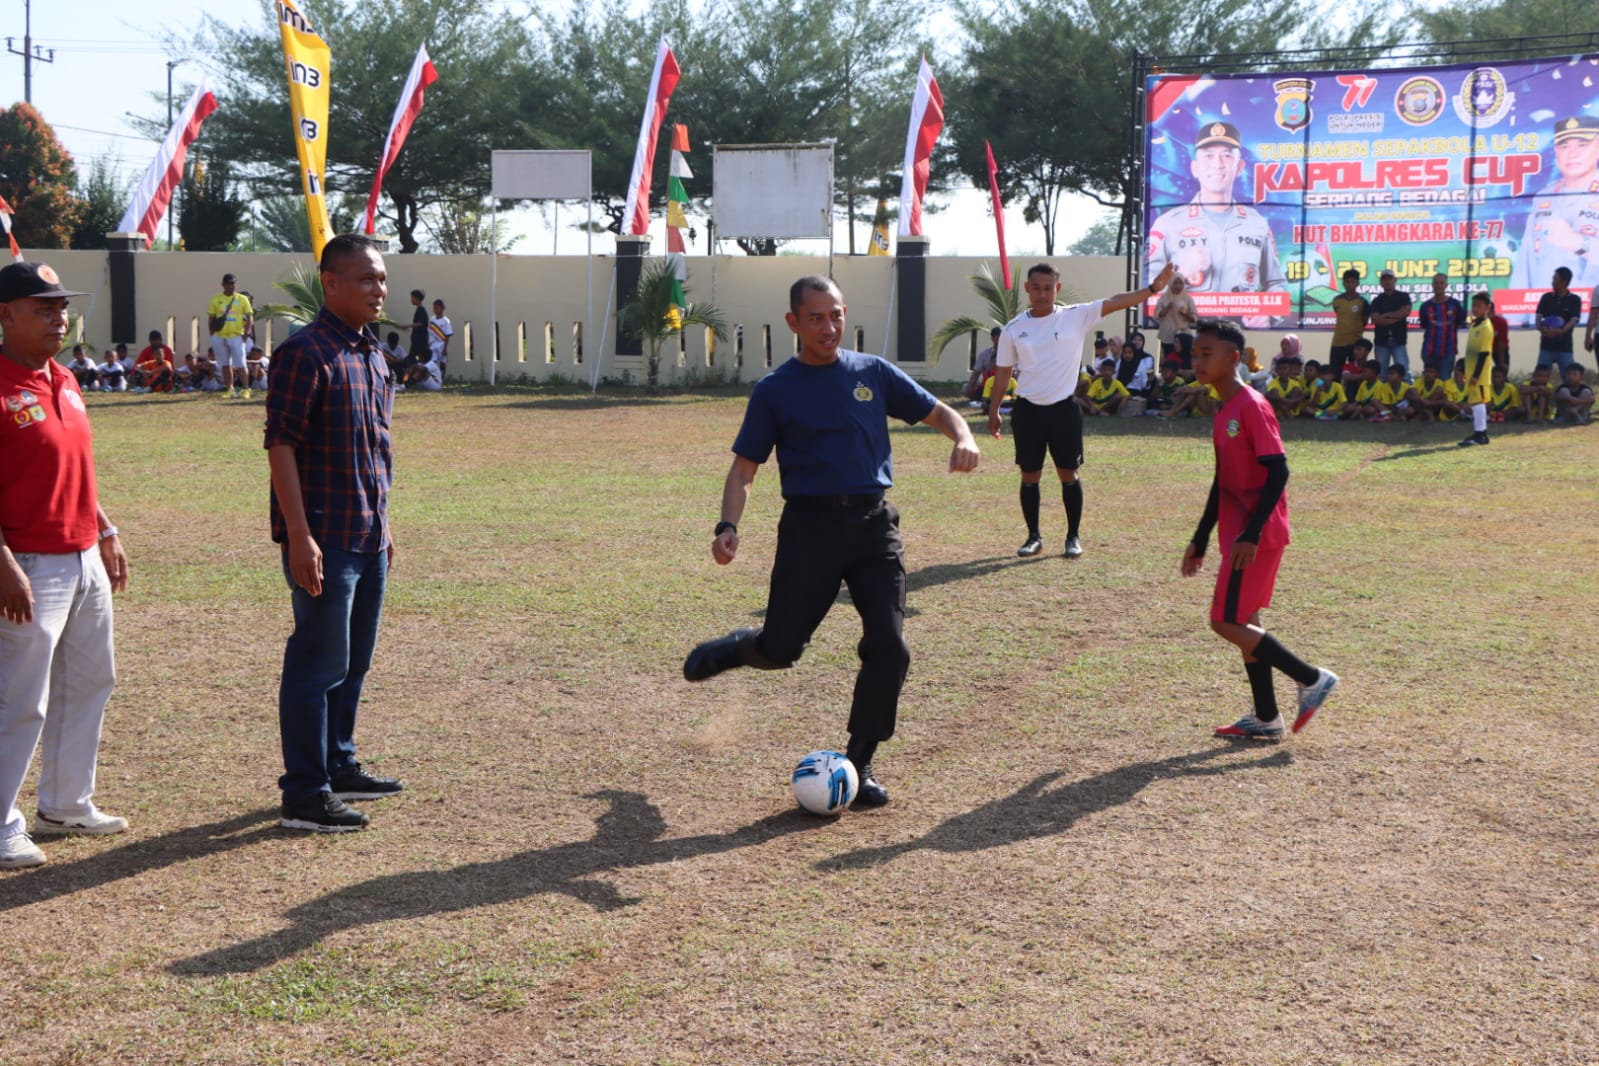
[1145, 54, 1599, 329]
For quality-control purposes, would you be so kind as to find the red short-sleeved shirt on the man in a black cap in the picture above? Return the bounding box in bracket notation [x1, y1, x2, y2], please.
[0, 355, 99, 555]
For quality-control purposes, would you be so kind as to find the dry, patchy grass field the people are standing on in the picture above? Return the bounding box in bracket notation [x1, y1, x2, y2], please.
[0, 392, 1599, 1066]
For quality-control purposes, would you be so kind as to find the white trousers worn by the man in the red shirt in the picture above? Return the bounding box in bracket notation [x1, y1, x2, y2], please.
[0, 547, 117, 837]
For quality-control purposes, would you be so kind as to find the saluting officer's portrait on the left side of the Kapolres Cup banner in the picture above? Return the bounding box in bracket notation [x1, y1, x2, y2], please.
[1145, 121, 1289, 329]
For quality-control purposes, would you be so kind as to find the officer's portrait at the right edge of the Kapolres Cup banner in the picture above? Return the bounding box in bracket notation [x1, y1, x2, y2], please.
[1509, 115, 1599, 298]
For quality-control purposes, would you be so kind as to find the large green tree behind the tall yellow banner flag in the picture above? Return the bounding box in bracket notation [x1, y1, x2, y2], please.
[173, 0, 539, 253]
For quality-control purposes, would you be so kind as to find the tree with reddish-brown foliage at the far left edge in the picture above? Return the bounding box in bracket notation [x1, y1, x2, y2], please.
[0, 104, 83, 248]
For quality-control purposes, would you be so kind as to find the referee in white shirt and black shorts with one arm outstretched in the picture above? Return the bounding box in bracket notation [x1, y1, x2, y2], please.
[988, 262, 1177, 559]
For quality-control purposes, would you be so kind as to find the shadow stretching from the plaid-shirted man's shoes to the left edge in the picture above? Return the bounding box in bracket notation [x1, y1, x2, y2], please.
[0, 807, 280, 911]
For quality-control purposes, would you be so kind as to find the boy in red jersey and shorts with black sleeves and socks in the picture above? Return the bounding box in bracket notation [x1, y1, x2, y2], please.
[1182, 321, 1338, 740]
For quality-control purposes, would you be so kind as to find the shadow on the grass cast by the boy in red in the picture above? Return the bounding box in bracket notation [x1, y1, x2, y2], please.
[815, 745, 1294, 871]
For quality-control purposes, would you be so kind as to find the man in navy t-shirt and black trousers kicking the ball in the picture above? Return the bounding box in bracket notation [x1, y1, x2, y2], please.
[683, 275, 977, 807]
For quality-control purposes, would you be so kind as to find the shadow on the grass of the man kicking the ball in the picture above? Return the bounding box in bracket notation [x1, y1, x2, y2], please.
[169, 790, 828, 977]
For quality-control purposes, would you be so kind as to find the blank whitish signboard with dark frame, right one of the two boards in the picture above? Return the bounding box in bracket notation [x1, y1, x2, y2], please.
[712, 144, 833, 240]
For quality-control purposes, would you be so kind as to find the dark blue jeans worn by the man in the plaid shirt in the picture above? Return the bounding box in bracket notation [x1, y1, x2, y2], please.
[278, 548, 389, 802]
